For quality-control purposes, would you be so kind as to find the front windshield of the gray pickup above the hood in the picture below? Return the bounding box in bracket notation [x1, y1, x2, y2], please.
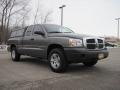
[44, 25, 74, 33]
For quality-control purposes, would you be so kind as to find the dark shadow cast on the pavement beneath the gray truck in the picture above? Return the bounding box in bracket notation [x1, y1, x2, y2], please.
[20, 57, 102, 73]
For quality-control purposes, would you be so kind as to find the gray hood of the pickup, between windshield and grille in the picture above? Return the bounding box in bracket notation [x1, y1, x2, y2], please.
[48, 33, 91, 39]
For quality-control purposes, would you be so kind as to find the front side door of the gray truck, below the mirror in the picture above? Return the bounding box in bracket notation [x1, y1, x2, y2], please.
[32, 25, 46, 58]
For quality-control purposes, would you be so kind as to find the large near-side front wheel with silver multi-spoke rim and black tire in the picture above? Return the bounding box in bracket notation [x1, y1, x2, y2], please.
[48, 49, 68, 73]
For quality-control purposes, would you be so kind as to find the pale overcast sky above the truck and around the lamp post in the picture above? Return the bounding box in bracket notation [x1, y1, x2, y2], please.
[30, 0, 120, 36]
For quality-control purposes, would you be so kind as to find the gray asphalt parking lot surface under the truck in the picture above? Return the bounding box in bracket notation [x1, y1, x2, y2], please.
[0, 48, 120, 90]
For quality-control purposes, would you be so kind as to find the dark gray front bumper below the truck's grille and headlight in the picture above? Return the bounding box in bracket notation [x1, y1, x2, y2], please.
[64, 48, 109, 63]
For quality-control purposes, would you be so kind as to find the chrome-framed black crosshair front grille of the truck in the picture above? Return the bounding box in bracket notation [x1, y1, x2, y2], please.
[86, 38, 104, 49]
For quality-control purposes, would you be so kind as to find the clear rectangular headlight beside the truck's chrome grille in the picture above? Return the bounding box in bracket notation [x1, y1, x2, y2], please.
[69, 39, 83, 47]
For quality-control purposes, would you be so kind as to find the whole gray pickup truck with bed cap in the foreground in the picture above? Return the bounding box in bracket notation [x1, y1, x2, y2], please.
[8, 24, 108, 72]
